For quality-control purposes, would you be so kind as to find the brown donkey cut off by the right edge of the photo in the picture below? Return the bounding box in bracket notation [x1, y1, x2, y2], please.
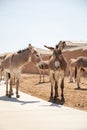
[75, 56, 87, 89]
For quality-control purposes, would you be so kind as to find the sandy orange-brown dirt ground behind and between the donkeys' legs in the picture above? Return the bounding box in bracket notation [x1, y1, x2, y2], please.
[19, 74, 87, 111]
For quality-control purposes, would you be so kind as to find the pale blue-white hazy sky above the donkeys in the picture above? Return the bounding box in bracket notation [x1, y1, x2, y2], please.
[0, 0, 87, 53]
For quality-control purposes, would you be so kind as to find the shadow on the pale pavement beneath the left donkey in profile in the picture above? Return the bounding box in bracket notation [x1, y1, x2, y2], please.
[0, 96, 40, 105]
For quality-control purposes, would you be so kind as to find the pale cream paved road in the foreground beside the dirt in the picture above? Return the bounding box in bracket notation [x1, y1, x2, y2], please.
[0, 80, 87, 130]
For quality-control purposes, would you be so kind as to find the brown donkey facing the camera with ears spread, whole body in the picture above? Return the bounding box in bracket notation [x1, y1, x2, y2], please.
[45, 41, 67, 102]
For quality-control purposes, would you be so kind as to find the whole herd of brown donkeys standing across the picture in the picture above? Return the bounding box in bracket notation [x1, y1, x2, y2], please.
[0, 41, 87, 102]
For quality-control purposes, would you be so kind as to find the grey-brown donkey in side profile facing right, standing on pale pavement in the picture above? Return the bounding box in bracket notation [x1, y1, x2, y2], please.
[3, 44, 40, 98]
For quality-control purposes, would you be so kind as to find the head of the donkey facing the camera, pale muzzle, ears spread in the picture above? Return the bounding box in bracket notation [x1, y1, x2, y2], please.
[45, 41, 66, 69]
